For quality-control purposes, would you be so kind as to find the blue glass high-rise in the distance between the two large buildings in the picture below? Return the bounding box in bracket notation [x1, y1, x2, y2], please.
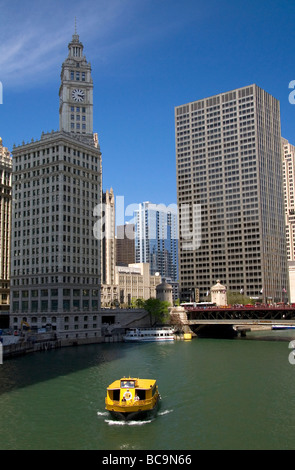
[134, 202, 178, 281]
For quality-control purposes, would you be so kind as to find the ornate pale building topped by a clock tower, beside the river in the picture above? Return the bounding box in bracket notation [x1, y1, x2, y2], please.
[10, 34, 102, 340]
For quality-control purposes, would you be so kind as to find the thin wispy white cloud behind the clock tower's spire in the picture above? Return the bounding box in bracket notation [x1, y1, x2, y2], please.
[0, 0, 194, 90]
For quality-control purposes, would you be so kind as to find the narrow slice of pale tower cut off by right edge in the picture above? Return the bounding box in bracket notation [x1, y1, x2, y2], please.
[282, 138, 295, 303]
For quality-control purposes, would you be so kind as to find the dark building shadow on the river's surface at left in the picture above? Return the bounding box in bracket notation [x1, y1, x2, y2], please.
[0, 343, 140, 395]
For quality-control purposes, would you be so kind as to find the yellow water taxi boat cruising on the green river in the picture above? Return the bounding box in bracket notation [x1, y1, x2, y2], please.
[105, 377, 161, 420]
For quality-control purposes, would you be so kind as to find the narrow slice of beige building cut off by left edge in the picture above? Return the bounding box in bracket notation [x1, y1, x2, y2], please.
[0, 137, 12, 310]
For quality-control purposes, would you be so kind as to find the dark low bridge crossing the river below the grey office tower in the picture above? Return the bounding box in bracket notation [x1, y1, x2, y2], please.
[177, 305, 295, 336]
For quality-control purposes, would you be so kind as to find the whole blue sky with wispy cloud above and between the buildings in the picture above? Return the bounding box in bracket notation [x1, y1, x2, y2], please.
[0, 0, 295, 217]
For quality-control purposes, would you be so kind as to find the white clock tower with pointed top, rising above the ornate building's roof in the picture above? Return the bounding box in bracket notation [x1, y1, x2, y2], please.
[59, 31, 93, 143]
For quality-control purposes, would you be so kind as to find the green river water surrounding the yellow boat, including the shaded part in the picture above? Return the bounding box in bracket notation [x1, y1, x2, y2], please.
[0, 331, 295, 451]
